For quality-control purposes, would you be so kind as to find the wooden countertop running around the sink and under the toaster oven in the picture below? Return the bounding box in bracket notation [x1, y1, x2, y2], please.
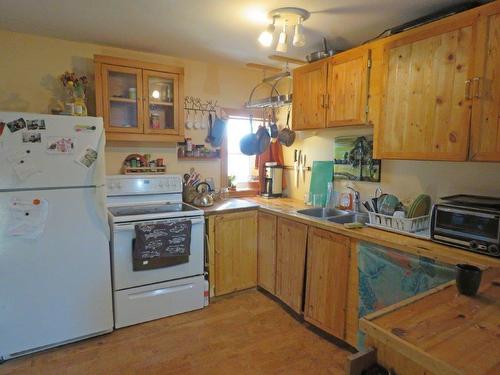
[245, 197, 500, 267]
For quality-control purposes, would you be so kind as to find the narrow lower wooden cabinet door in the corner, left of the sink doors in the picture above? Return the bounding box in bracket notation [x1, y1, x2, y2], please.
[257, 212, 277, 294]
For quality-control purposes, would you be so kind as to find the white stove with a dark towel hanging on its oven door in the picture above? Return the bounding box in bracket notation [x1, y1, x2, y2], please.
[106, 175, 205, 328]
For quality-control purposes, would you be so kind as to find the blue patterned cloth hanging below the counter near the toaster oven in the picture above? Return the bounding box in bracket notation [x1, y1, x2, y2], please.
[357, 242, 455, 350]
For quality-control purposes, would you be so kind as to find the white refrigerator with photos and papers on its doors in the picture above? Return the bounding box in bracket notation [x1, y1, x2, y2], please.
[0, 112, 113, 361]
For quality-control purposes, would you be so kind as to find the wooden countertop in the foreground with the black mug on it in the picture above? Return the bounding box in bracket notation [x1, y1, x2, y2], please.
[360, 268, 500, 375]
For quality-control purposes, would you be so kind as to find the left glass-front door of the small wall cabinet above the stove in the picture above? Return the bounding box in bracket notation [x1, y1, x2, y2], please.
[102, 65, 143, 133]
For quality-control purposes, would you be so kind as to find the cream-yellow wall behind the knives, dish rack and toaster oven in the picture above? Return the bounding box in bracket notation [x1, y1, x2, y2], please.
[280, 114, 500, 201]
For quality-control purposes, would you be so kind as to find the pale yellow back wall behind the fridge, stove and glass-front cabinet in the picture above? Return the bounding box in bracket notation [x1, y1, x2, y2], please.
[0, 30, 261, 184]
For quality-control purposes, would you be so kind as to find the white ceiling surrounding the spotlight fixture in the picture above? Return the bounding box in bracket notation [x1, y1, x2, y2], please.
[0, 0, 463, 64]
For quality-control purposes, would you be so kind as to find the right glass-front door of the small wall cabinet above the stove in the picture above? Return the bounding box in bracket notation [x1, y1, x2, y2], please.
[143, 70, 180, 134]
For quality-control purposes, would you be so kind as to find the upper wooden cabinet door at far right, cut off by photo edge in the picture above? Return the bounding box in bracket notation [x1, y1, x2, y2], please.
[470, 2, 500, 161]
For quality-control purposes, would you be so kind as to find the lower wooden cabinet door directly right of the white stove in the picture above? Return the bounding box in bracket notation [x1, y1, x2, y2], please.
[213, 210, 257, 296]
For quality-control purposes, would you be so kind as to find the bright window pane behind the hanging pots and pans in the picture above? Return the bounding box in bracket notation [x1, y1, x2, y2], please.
[227, 117, 262, 184]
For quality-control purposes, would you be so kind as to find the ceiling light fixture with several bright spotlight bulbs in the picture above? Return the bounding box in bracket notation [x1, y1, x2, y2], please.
[258, 7, 310, 53]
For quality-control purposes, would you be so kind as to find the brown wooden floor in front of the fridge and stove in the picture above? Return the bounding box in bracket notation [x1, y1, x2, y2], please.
[0, 290, 349, 375]
